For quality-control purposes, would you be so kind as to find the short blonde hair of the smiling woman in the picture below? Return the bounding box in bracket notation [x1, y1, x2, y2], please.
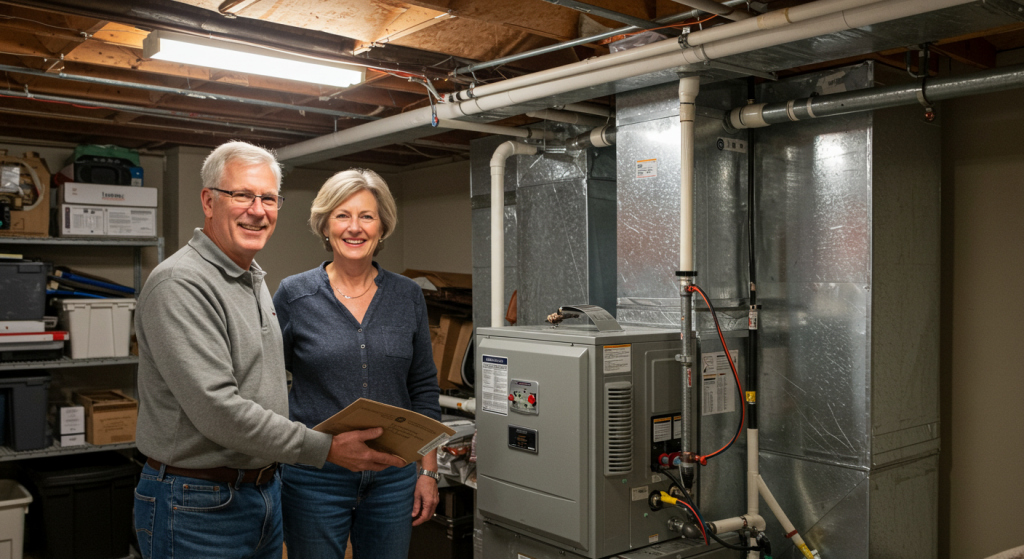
[309, 169, 398, 251]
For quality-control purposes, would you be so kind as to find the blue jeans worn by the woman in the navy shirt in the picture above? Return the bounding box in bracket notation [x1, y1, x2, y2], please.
[281, 463, 419, 559]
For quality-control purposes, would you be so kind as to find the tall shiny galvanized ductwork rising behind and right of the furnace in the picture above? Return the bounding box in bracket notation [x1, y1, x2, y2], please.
[616, 62, 941, 559]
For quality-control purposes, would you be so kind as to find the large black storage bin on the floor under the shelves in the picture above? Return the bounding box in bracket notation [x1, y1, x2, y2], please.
[19, 452, 139, 559]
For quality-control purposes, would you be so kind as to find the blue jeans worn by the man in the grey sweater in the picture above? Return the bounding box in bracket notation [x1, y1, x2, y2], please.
[135, 465, 283, 559]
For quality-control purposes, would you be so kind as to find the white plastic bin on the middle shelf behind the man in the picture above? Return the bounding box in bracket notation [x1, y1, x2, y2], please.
[60, 299, 135, 359]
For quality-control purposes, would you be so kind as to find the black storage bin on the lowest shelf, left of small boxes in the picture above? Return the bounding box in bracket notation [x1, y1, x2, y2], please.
[0, 371, 51, 452]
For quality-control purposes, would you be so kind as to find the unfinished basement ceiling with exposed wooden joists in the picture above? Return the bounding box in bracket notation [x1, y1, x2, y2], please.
[0, 0, 1024, 167]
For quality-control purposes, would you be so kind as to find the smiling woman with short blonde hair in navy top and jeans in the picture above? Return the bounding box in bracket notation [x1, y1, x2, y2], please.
[273, 170, 440, 559]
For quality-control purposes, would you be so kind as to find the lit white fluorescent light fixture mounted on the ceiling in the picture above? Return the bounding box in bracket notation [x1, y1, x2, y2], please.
[142, 31, 366, 87]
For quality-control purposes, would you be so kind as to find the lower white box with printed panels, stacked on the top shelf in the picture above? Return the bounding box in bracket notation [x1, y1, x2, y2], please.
[58, 204, 157, 237]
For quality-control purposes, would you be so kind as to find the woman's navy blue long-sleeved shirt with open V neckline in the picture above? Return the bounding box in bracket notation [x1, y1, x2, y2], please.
[273, 262, 441, 427]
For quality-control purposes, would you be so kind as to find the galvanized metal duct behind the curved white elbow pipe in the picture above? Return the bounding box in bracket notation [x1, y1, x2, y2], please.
[470, 123, 615, 325]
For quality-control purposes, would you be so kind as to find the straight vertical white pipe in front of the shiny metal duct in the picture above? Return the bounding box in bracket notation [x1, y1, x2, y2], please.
[679, 76, 700, 271]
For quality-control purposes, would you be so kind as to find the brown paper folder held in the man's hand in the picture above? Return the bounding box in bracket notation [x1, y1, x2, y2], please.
[313, 398, 455, 464]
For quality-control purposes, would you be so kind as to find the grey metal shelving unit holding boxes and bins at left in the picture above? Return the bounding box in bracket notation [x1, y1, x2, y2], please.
[0, 237, 164, 462]
